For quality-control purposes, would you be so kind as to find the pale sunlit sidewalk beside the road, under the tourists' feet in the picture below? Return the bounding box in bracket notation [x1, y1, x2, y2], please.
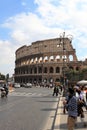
[54, 97, 87, 130]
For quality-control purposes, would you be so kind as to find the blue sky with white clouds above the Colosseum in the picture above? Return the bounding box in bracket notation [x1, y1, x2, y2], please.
[0, 0, 87, 76]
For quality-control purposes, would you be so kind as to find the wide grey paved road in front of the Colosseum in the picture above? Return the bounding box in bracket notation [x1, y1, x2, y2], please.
[0, 88, 58, 130]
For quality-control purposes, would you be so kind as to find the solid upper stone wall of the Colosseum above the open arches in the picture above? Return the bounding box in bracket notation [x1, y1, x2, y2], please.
[16, 38, 77, 61]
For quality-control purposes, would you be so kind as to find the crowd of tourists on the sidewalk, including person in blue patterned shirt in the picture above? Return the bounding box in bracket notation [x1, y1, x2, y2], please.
[63, 85, 87, 130]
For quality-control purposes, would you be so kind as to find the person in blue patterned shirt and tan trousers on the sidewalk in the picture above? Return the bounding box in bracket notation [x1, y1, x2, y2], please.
[64, 88, 78, 130]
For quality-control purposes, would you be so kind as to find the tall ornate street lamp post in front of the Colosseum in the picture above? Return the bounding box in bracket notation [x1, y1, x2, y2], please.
[57, 32, 72, 86]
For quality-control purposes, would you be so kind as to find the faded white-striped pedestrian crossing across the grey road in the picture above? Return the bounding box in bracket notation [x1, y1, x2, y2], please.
[9, 92, 49, 97]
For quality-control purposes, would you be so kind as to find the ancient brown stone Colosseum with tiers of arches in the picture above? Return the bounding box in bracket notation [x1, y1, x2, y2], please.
[15, 37, 82, 83]
